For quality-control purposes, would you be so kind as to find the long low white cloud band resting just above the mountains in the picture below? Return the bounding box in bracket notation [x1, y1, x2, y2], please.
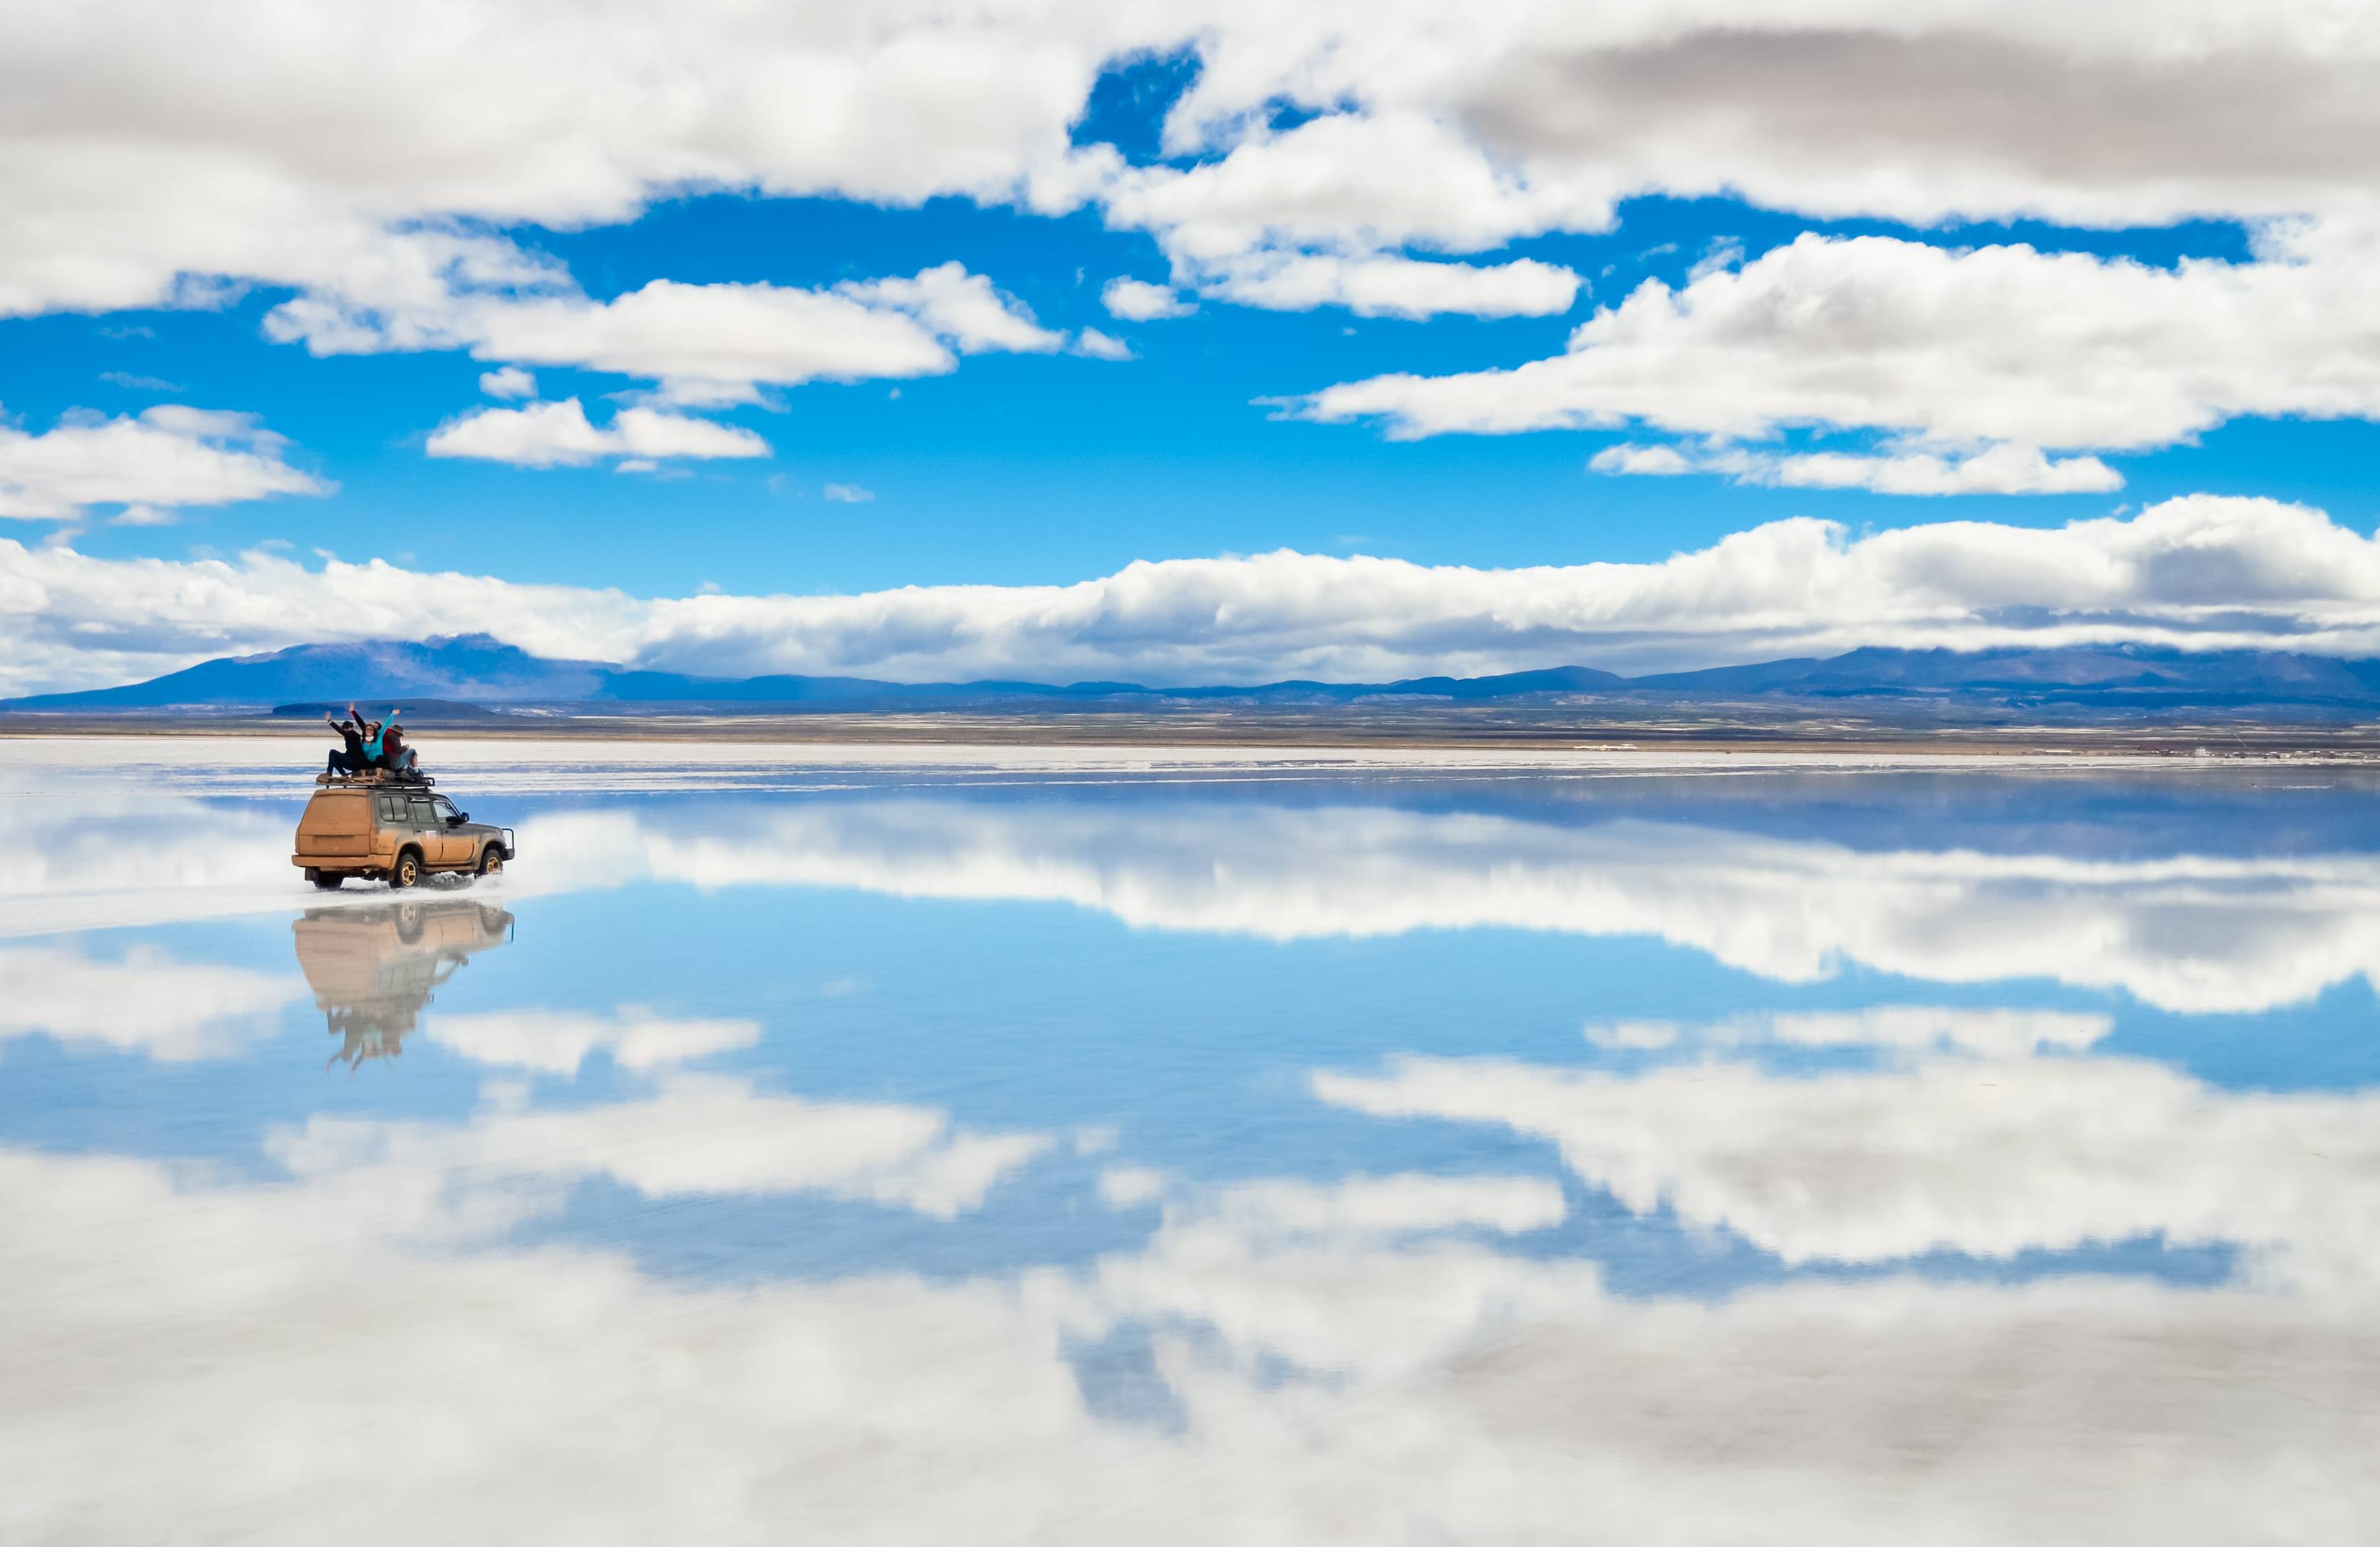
[14, 495, 2380, 690]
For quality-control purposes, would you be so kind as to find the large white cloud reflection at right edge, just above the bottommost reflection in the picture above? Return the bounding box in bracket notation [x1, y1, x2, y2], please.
[1314, 1054, 2380, 1283]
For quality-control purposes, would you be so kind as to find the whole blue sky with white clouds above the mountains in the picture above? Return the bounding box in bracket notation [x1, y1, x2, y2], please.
[0, 0, 2380, 688]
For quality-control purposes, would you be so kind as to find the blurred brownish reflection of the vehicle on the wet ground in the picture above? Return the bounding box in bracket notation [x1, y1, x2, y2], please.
[291, 899, 512, 1069]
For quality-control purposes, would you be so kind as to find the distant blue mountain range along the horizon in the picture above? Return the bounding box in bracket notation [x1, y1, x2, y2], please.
[0, 633, 2380, 716]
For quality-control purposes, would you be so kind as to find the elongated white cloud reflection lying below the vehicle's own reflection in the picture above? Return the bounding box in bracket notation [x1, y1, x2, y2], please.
[274, 1076, 1049, 1219]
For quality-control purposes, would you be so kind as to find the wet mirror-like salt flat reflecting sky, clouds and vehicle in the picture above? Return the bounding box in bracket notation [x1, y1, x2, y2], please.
[0, 740, 2380, 1545]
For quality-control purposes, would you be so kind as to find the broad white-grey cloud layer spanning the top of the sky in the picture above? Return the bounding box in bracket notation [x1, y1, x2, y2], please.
[14, 0, 2380, 363]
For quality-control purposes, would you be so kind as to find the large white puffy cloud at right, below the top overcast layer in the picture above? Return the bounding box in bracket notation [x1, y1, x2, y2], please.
[1302, 231, 2380, 462]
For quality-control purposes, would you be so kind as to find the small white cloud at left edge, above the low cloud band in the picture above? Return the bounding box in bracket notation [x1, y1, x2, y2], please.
[0, 405, 333, 524]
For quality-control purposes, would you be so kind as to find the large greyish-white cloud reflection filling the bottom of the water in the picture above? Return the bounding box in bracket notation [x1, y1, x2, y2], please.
[0, 1152, 2380, 1547]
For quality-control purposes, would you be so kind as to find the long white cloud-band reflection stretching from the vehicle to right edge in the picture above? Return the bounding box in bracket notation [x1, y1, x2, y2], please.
[524, 800, 2380, 1012]
